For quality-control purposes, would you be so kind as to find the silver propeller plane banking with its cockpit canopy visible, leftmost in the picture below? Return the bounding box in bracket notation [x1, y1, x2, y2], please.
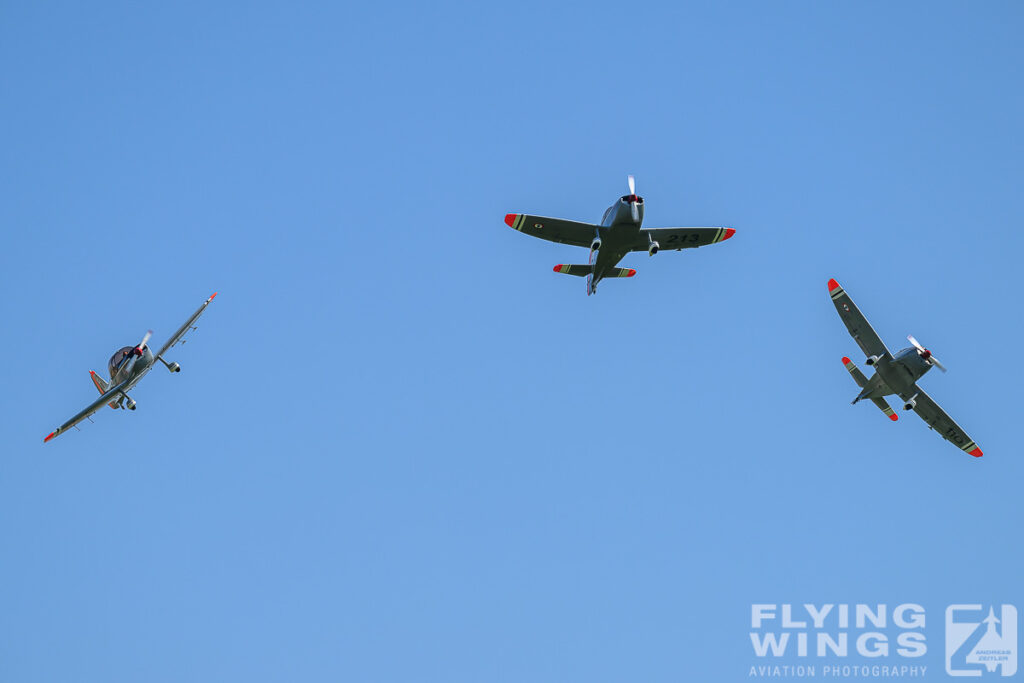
[43, 292, 217, 442]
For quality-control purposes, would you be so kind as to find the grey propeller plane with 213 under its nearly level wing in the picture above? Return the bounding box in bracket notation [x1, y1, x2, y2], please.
[505, 175, 736, 296]
